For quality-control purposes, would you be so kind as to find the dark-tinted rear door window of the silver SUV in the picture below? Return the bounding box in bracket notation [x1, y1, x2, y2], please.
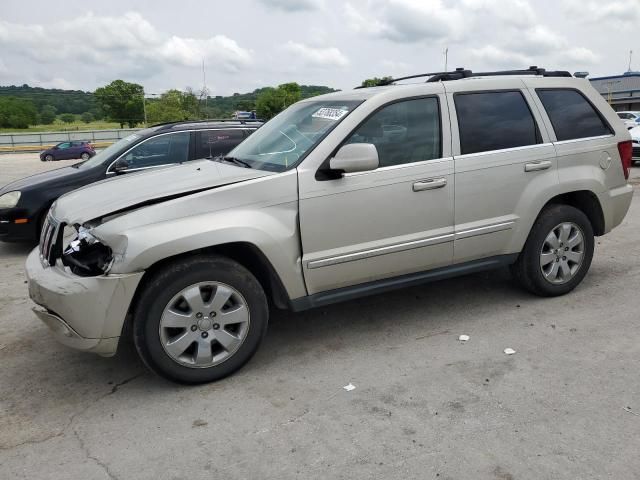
[453, 91, 540, 155]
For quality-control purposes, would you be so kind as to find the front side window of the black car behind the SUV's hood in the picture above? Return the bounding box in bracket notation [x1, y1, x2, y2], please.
[123, 132, 191, 169]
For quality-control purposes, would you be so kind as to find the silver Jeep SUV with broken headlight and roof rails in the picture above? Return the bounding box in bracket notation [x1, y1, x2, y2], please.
[26, 68, 632, 383]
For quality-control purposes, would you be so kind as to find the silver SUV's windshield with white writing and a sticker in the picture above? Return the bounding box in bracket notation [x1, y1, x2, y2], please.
[228, 100, 362, 172]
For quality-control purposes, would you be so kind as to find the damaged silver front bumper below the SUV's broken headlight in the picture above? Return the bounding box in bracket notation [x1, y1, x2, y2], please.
[26, 248, 144, 356]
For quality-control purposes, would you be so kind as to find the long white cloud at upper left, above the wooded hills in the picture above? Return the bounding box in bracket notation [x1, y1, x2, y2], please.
[0, 12, 252, 76]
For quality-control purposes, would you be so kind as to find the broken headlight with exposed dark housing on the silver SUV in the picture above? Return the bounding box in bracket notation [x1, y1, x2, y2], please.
[62, 226, 113, 277]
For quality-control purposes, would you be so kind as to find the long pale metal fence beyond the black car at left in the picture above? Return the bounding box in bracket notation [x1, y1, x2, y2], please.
[0, 128, 142, 153]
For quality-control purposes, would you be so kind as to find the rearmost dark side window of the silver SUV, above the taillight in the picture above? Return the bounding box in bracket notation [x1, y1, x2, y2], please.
[536, 89, 613, 141]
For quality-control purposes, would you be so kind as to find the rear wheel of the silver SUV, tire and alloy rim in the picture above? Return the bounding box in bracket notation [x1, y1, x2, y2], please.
[511, 205, 594, 297]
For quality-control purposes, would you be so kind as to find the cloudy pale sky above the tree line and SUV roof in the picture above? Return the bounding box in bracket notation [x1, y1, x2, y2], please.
[0, 0, 640, 95]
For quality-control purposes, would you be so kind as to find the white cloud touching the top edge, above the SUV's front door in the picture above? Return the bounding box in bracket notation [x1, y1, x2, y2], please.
[344, 0, 466, 43]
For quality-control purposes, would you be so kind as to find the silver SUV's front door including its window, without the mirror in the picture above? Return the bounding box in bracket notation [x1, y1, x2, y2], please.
[300, 95, 454, 294]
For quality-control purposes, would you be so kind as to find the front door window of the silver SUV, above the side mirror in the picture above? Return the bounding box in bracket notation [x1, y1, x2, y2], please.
[346, 97, 441, 167]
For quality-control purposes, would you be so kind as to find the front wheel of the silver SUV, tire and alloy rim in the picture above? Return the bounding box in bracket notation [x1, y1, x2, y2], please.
[133, 256, 269, 384]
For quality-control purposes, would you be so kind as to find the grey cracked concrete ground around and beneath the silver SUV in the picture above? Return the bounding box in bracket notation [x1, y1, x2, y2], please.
[0, 155, 640, 480]
